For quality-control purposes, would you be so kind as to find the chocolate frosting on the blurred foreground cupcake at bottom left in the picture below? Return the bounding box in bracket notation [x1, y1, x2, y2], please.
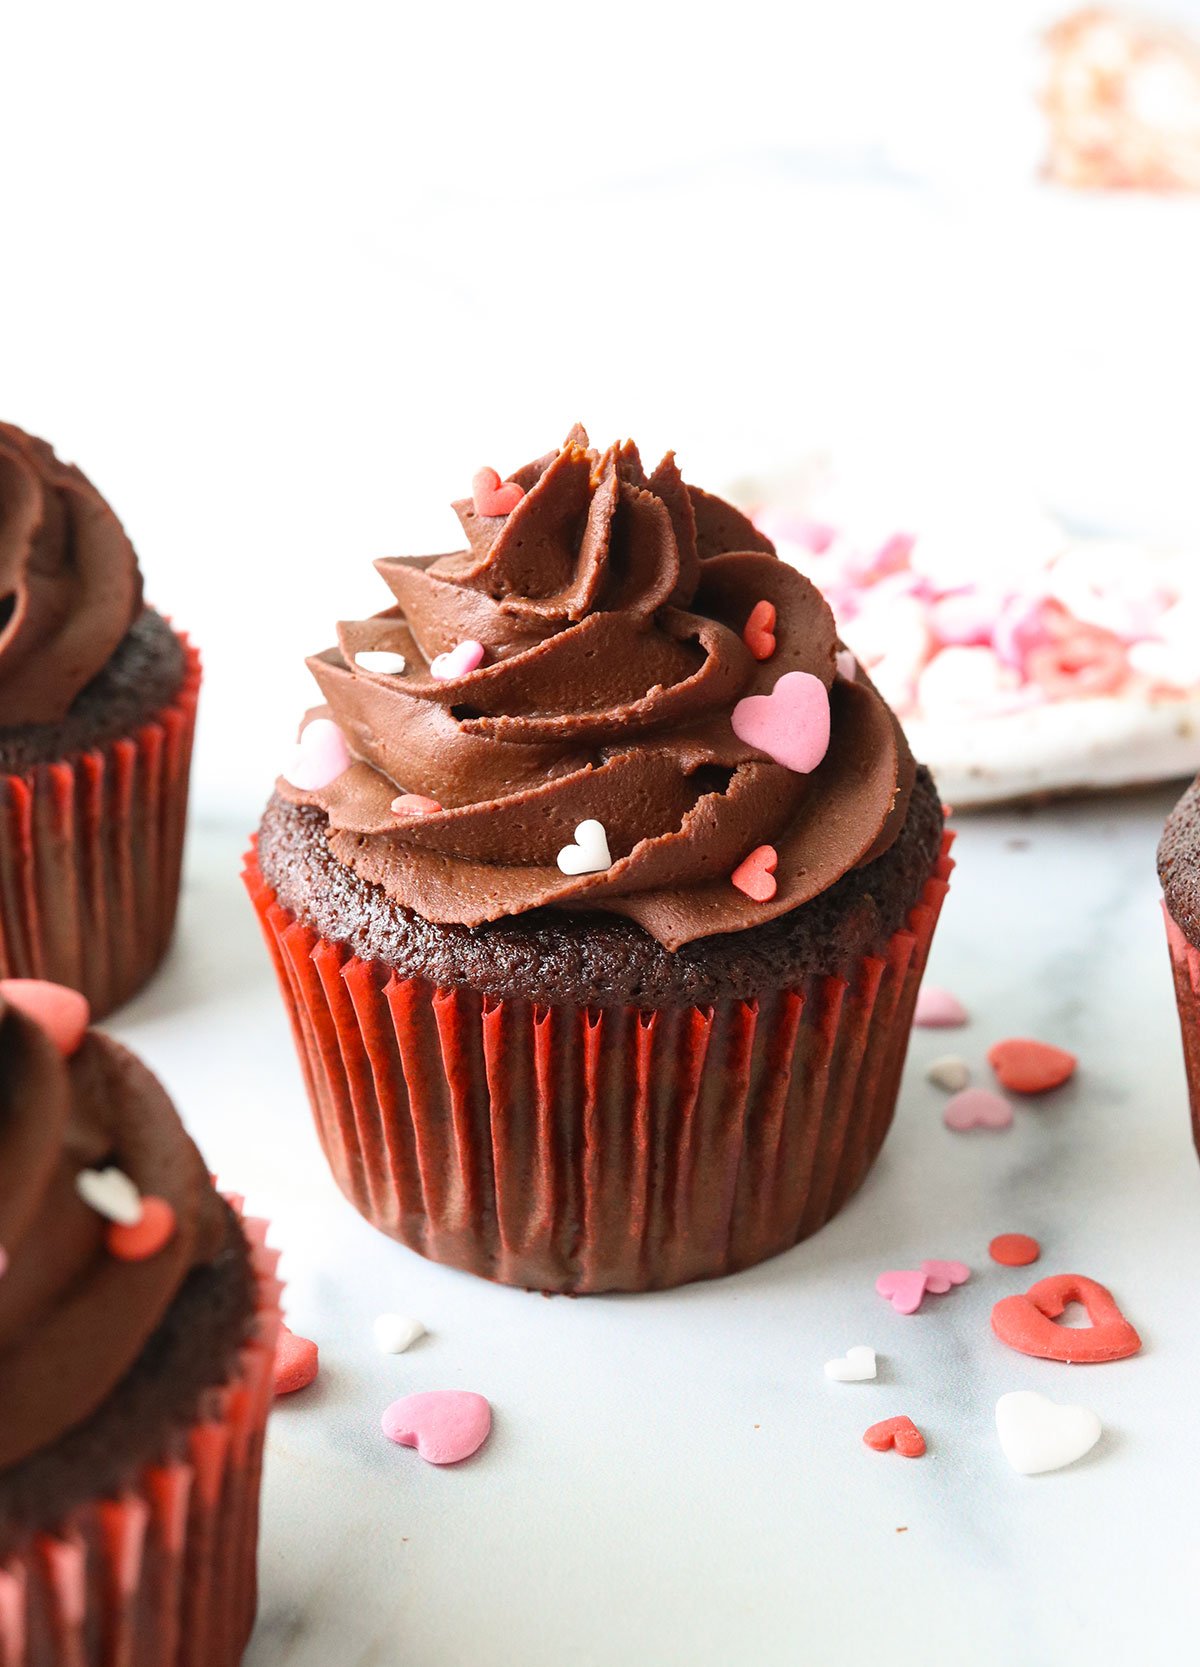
[0, 1000, 225, 1470]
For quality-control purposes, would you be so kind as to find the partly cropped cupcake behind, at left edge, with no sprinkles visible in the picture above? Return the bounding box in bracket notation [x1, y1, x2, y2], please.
[0, 423, 200, 1017]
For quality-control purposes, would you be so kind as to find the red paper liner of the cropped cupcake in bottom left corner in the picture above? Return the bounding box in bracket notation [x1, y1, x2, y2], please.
[0, 1199, 282, 1667]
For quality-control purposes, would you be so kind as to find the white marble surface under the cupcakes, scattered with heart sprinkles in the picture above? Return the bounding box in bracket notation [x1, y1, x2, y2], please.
[105, 790, 1200, 1667]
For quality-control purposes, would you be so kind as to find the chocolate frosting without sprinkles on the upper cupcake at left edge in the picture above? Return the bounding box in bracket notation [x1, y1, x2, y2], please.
[0, 423, 142, 727]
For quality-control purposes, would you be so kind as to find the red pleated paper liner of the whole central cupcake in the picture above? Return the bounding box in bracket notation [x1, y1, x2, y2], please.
[245, 834, 953, 1292]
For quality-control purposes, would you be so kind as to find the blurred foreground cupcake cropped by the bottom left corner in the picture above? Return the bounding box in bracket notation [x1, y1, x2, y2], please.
[0, 980, 278, 1667]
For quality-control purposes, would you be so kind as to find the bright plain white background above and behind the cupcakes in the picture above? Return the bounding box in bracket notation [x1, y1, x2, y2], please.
[0, 0, 1200, 827]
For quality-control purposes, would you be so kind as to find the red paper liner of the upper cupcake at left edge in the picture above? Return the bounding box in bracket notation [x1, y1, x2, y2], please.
[0, 637, 200, 1019]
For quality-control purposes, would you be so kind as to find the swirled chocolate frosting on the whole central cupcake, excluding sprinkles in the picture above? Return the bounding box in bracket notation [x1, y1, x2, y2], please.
[278, 428, 915, 949]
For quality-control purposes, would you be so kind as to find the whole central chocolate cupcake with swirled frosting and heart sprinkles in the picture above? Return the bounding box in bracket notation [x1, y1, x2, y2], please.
[247, 428, 950, 1292]
